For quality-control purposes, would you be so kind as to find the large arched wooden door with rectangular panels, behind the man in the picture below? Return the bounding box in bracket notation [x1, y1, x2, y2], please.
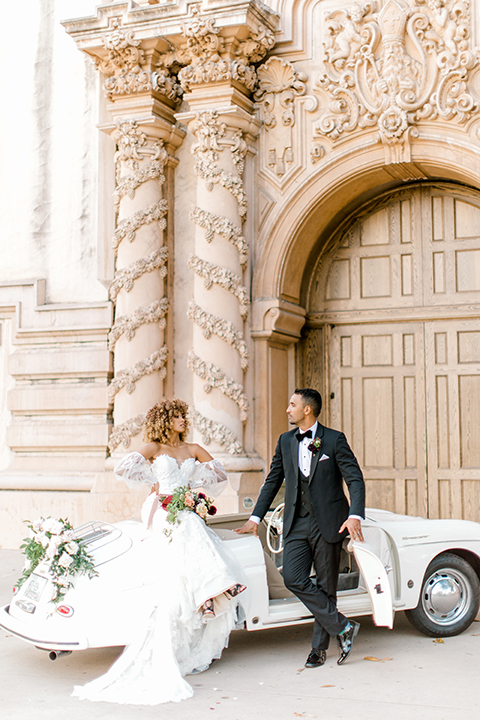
[299, 183, 480, 521]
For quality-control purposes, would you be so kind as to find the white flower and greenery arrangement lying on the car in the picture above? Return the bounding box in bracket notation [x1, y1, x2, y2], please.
[15, 517, 98, 604]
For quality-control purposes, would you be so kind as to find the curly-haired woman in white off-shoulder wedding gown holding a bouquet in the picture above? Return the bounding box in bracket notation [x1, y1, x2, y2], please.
[73, 399, 245, 705]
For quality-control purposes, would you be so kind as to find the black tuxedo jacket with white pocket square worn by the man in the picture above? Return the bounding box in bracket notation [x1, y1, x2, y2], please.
[252, 423, 365, 543]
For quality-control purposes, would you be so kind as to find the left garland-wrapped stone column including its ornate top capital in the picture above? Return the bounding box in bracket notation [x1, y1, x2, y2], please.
[63, 15, 185, 454]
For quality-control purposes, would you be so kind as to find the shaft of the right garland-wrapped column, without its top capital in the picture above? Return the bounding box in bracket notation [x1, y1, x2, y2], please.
[188, 110, 249, 453]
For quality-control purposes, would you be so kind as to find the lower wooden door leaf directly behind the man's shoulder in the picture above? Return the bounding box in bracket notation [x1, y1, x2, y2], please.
[330, 323, 426, 515]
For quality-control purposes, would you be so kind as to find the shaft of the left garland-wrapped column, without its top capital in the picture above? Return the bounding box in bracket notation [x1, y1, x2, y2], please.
[108, 120, 169, 450]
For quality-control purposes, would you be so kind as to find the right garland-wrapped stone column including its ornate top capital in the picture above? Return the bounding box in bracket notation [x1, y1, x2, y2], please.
[178, 6, 274, 462]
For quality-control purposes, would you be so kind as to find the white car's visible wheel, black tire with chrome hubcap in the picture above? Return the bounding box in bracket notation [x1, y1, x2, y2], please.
[405, 553, 480, 637]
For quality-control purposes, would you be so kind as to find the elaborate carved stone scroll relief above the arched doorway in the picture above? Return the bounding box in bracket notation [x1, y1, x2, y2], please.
[316, 0, 479, 162]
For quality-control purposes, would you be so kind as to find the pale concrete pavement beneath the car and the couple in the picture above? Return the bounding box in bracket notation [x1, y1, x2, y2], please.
[0, 550, 480, 720]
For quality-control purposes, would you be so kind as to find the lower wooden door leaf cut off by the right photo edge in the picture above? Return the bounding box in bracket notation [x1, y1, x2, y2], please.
[425, 320, 480, 522]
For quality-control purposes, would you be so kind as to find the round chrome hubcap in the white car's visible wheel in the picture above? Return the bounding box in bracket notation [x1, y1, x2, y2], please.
[422, 568, 470, 625]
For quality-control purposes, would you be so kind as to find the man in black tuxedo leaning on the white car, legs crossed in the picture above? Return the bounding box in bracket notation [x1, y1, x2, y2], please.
[237, 388, 365, 668]
